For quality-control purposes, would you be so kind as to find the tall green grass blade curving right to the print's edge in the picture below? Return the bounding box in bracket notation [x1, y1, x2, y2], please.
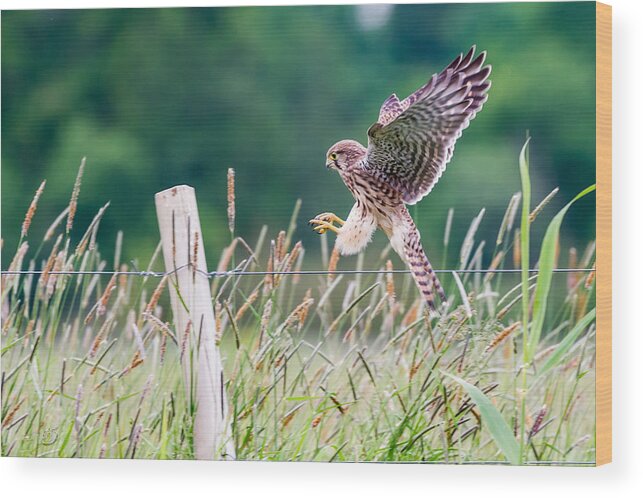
[525, 185, 596, 362]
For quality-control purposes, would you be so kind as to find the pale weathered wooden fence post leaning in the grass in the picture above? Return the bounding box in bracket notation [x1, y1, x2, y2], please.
[155, 185, 235, 460]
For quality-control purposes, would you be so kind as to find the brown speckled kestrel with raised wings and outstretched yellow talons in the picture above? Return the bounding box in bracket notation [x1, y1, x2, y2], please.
[310, 46, 491, 310]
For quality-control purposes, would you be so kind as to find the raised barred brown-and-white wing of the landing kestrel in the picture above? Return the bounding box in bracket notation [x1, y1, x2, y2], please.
[366, 46, 491, 204]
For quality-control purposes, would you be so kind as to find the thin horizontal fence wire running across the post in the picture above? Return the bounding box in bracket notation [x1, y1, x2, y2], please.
[0, 263, 595, 278]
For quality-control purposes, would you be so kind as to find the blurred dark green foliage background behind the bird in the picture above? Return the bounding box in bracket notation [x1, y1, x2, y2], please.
[2, 2, 595, 267]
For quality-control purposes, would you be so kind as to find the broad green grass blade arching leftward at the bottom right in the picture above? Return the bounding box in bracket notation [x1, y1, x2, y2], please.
[442, 372, 521, 465]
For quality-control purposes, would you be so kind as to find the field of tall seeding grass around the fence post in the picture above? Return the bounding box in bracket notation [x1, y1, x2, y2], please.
[2, 142, 595, 464]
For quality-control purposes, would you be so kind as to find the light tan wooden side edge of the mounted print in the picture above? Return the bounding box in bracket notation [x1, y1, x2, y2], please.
[596, 3, 612, 465]
